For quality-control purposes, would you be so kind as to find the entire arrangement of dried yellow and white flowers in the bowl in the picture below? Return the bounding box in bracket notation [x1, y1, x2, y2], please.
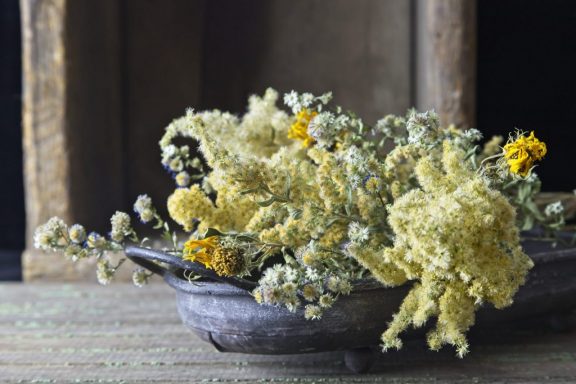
[34, 89, 564, 356]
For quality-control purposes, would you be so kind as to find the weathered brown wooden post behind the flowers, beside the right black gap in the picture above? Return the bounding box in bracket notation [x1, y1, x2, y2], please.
[416, 0, 476, 128]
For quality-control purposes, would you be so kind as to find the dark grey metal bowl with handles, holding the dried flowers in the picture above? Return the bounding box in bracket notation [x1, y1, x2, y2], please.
[126, 237, 576, 366]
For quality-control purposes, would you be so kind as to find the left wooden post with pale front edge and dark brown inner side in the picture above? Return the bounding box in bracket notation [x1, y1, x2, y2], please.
[20, 0, 123, 280]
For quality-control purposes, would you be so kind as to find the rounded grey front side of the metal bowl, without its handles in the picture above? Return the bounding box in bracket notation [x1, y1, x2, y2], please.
[170, 275, 407, 354]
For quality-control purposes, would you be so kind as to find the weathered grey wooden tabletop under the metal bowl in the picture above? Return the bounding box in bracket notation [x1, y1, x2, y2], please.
[0, 283, 576, 383]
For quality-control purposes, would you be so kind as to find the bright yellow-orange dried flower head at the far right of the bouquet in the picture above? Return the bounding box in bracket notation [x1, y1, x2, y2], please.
[504, 131, 546, 177]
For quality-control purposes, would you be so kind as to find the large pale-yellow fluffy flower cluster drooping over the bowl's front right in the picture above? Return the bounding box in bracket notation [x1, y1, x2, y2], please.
[350, 142, 533, 356]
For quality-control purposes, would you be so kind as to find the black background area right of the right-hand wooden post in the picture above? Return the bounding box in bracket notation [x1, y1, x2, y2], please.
[477, 0, 576, 191]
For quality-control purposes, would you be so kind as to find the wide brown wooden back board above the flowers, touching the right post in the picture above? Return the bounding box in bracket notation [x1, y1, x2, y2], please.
[202, 0, 414, 124]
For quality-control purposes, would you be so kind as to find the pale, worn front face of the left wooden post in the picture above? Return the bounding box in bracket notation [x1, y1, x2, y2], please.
[20, 0, 72, 279]
